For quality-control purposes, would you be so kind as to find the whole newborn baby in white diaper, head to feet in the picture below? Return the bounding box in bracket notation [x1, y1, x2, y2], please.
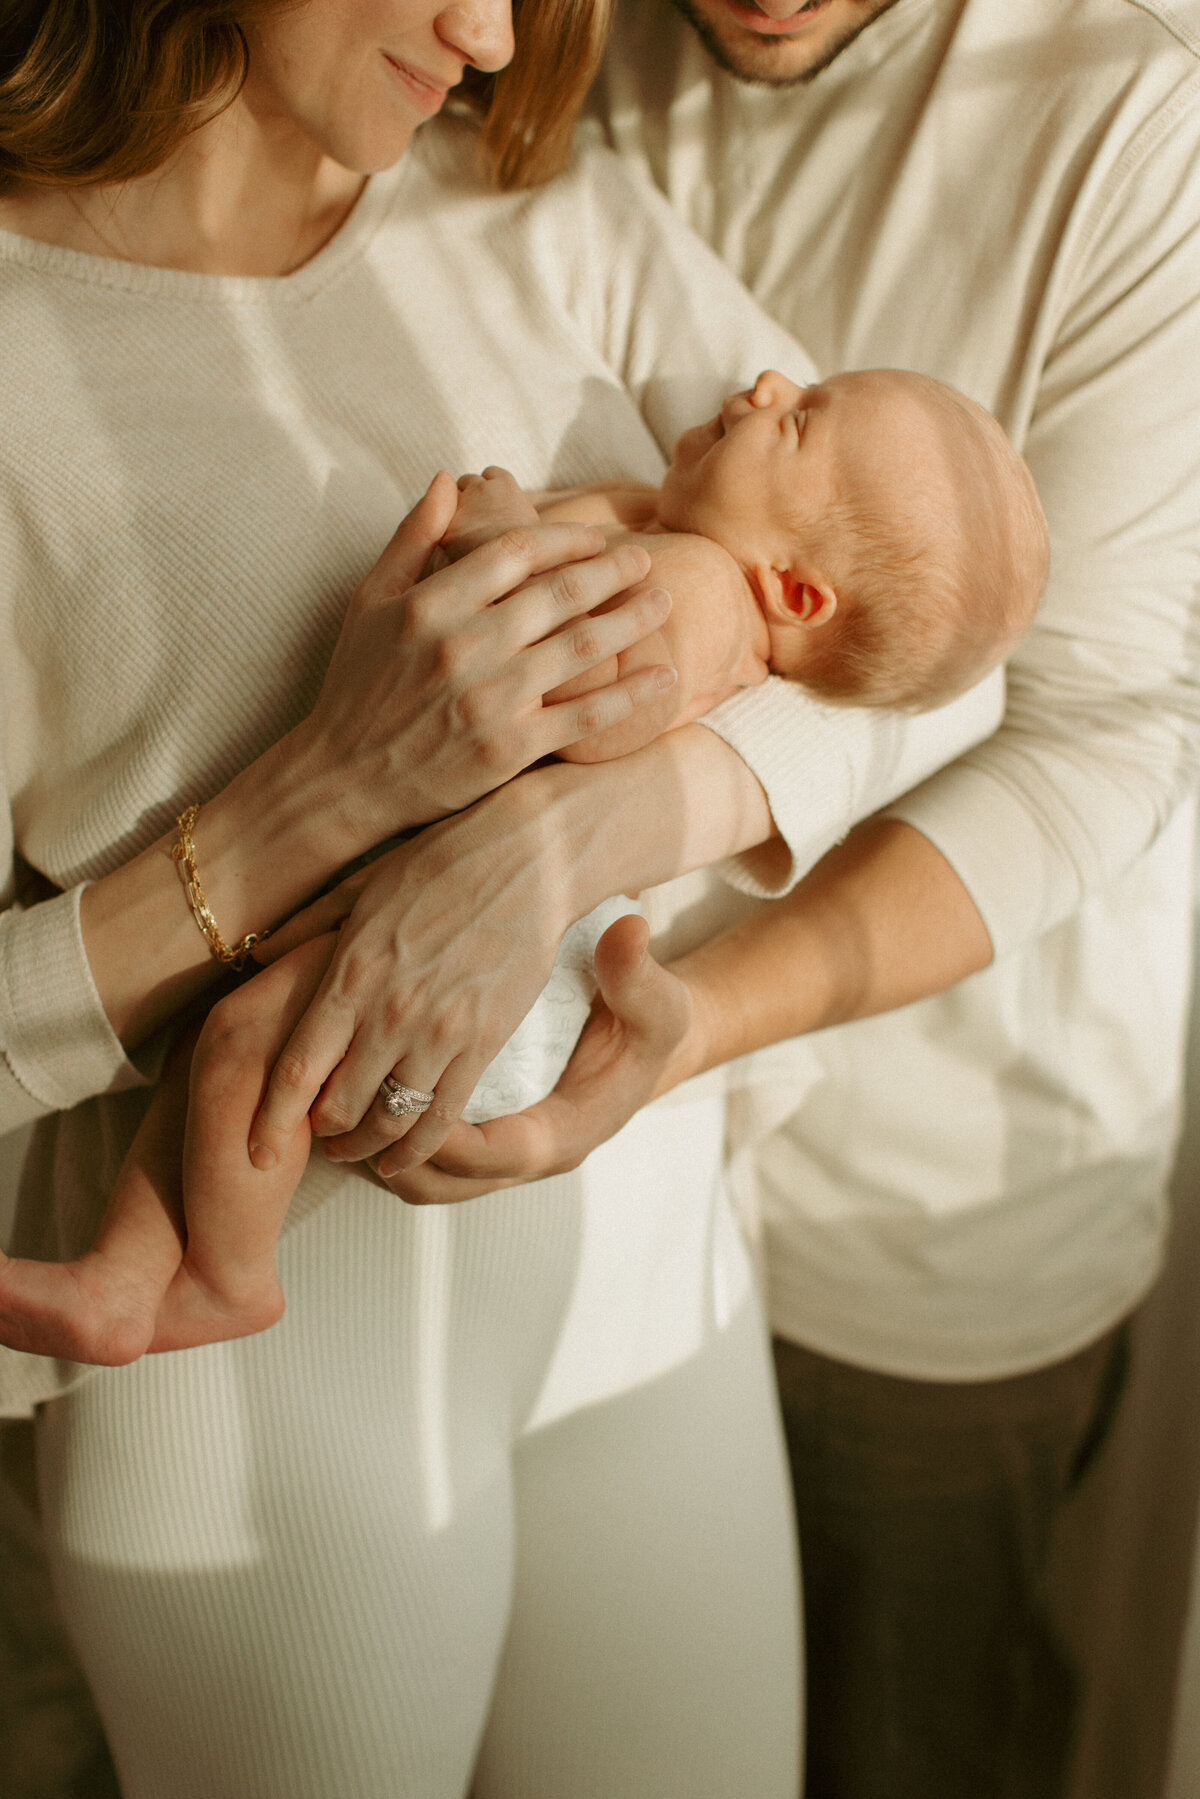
[0, 371, 1047, 1362]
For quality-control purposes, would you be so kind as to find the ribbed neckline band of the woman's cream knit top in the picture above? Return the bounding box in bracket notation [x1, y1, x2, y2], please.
[0, 149, 412, 302]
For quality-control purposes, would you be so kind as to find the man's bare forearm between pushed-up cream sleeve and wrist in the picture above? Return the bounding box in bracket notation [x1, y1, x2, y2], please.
[658, 819, 991, 1092]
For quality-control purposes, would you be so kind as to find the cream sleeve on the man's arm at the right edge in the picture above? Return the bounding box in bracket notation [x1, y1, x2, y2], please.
[892, 88, 1200, 955]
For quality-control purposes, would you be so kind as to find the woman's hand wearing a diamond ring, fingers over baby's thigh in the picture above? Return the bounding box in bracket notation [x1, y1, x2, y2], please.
[250, 777, 587, 1168]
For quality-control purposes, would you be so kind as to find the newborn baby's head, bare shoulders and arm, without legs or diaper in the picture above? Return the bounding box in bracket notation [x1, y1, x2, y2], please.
[543, 369, 1049, 761]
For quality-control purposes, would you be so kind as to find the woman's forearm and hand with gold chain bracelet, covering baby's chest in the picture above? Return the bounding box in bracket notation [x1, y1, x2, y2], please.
[83, 477, 683, 1049]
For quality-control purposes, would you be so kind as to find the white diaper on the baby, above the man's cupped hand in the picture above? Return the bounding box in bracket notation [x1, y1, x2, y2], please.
[462, 894, 642, 1124]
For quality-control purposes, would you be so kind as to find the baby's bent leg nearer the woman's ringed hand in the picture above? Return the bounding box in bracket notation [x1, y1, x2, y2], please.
[151, 934, 336, 1351]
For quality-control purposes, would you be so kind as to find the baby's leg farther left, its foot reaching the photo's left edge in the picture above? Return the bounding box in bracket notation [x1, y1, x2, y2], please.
[0, 1031, 196, 1367]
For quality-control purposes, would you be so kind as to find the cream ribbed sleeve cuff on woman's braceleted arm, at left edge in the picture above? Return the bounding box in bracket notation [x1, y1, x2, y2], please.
[0, 887, 144, 1130]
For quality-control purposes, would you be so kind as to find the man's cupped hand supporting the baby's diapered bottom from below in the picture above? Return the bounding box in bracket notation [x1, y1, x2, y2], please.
[372, 917, 703, 1205]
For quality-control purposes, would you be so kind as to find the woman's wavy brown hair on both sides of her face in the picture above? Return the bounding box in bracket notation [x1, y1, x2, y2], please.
[0, 0, 612, 192]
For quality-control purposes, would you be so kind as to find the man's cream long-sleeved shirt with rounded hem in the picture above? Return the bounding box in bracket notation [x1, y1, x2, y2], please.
[596, 0, 1200, 1380]
